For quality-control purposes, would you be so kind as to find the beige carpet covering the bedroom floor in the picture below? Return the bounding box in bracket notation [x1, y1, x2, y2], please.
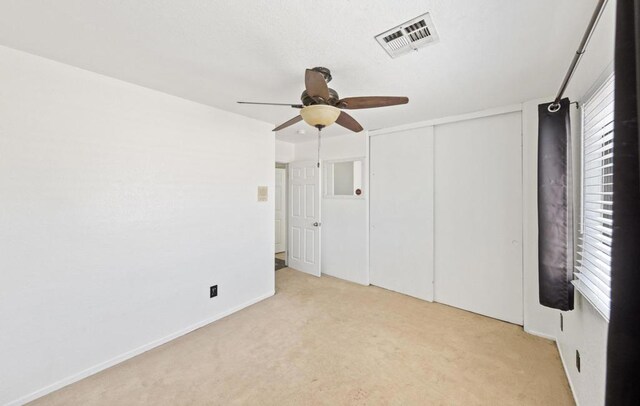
[30, 268, 573, 405]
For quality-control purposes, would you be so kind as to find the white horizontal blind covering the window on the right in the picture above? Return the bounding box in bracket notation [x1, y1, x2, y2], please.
[574, 75, 614, 320]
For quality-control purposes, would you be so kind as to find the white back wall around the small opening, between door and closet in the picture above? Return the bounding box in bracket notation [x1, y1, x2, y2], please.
[295, 132, 369, 285]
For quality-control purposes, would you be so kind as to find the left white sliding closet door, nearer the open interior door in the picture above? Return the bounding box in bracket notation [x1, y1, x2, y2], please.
[369, 127, 433, 301]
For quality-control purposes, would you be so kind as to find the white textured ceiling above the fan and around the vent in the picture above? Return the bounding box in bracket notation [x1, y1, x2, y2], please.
[0, 0, 611, 142]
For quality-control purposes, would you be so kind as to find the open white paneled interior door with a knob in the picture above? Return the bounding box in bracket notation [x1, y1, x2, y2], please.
[288, 161, 320, 276]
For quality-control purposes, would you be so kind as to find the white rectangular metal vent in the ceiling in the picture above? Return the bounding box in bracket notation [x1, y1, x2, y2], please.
[376, 13, 438, 58]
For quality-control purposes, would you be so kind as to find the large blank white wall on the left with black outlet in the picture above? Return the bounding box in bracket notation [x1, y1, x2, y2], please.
[0, 47, 275, 404]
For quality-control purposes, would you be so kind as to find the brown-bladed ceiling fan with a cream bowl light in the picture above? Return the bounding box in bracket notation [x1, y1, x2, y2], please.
[238, 67, 409, 132]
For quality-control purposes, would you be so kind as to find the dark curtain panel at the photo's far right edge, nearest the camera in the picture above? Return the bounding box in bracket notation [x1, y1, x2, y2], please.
[606, 0, 640, 406]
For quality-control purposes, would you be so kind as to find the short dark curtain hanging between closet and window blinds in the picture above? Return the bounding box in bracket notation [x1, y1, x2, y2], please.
[538, 99, 573, 310]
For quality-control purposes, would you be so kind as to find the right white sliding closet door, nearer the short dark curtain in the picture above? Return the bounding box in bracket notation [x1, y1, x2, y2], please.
[435, 112, 522, 324]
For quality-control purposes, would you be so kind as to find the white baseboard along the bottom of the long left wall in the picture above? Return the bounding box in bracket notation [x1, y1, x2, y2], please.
[6, 291, 275, 406]
